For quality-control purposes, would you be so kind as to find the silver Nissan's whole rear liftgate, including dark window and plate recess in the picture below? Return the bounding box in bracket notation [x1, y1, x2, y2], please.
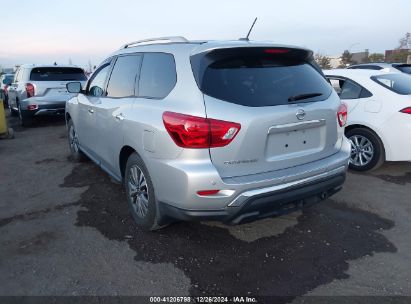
[191, 48, 342, 177]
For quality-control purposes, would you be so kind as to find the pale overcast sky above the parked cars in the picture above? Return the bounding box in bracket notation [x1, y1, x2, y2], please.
[0, 0, 411, 67]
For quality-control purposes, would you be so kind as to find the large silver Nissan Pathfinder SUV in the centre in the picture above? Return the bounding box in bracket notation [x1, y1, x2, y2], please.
[66, 37, 350, 229]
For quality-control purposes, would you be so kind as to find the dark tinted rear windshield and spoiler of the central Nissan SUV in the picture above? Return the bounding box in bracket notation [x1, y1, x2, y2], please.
[191, 47, 332, 107]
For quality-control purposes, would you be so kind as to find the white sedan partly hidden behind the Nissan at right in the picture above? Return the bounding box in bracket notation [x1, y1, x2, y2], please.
[324, 69, 411, 171]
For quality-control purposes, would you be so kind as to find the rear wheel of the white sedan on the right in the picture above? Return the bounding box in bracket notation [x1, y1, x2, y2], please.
[346, 128, 385, 172]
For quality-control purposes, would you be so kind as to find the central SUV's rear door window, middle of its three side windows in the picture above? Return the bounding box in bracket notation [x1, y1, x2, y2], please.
[107, 54, 142, 98]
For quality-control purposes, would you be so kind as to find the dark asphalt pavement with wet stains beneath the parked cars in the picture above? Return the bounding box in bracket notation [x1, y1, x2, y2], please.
[0, 112, 411, 301]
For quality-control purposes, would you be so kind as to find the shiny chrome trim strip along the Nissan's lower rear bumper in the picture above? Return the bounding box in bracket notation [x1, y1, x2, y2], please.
[228, 166, 347, 207]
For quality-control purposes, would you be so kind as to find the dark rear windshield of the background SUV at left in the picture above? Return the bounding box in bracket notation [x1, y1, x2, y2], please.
[30, 67, 87, 81]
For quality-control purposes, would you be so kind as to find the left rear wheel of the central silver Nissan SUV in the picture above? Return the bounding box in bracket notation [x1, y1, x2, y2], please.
[124, 153, 162, 231]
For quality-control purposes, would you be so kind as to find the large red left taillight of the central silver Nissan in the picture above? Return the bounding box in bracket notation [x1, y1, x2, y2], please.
[163, 112, 241, 149]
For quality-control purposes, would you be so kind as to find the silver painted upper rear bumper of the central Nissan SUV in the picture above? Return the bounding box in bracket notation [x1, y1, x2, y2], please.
[151, 138, 351, 213]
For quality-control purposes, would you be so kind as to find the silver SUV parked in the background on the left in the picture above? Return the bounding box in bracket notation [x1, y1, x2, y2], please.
[8, 64, 87, 126]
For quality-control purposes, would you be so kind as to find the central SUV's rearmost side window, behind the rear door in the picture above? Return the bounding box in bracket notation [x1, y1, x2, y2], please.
[138, 53, 177, 99]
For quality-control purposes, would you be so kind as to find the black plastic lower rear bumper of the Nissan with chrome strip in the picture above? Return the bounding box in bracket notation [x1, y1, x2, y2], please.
[159, 166, 346, 224]
